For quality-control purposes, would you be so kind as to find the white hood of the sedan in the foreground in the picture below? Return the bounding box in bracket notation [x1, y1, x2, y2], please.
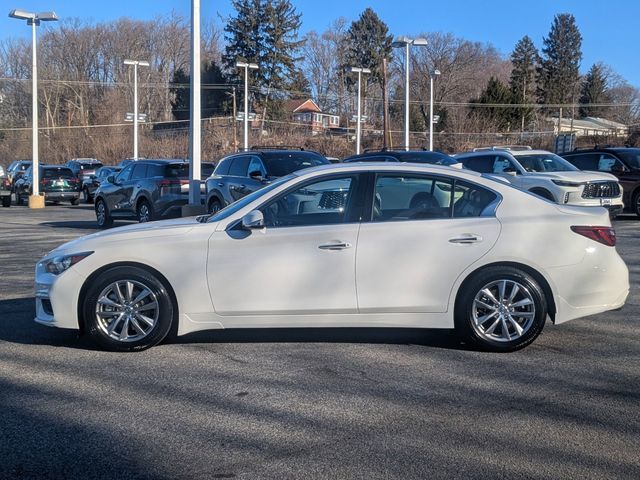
[47, 217, 198, 257]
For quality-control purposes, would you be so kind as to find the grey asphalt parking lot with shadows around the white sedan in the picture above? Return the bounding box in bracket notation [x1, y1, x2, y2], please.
[0, 205, 640, 479]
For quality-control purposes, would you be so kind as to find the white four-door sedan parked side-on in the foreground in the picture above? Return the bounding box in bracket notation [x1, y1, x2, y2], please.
[36, 163, 629, 351]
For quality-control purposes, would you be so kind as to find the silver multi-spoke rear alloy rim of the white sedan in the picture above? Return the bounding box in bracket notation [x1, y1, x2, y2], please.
[471, 279, 536, 342]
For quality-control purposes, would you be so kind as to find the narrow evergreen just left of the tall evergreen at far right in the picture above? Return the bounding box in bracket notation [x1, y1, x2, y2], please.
[509, 35, 540, 130]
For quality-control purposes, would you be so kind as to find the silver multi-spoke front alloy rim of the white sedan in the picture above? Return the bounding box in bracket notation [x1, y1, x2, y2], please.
[95, 280, 160, 342]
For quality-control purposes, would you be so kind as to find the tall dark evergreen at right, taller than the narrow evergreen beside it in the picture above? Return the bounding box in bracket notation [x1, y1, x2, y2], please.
[538, 13, 582, 109]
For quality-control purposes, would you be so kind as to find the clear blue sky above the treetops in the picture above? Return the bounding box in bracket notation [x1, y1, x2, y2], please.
[5, 0, 640, 87]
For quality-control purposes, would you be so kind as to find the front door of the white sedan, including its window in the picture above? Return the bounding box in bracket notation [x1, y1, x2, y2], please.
[207, 174, 362, 316]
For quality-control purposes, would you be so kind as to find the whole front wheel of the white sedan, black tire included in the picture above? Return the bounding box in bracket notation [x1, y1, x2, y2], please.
[82, 266, 177, 352]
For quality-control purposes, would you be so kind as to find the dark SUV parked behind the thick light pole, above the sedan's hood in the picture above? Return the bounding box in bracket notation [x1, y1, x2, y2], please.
[95, 160, 214, 228]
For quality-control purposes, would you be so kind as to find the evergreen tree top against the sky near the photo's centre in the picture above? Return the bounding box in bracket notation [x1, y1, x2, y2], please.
[341, 8, 393, 89]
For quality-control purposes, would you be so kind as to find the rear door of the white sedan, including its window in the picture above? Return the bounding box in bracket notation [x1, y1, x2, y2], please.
[356, 172, 500, 313]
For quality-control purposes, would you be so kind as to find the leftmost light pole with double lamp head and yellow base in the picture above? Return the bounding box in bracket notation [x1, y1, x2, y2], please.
[9, 9, 58, 208]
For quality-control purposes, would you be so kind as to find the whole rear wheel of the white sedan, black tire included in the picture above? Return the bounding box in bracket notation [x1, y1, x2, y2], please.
[455, 266, 547, 352]
